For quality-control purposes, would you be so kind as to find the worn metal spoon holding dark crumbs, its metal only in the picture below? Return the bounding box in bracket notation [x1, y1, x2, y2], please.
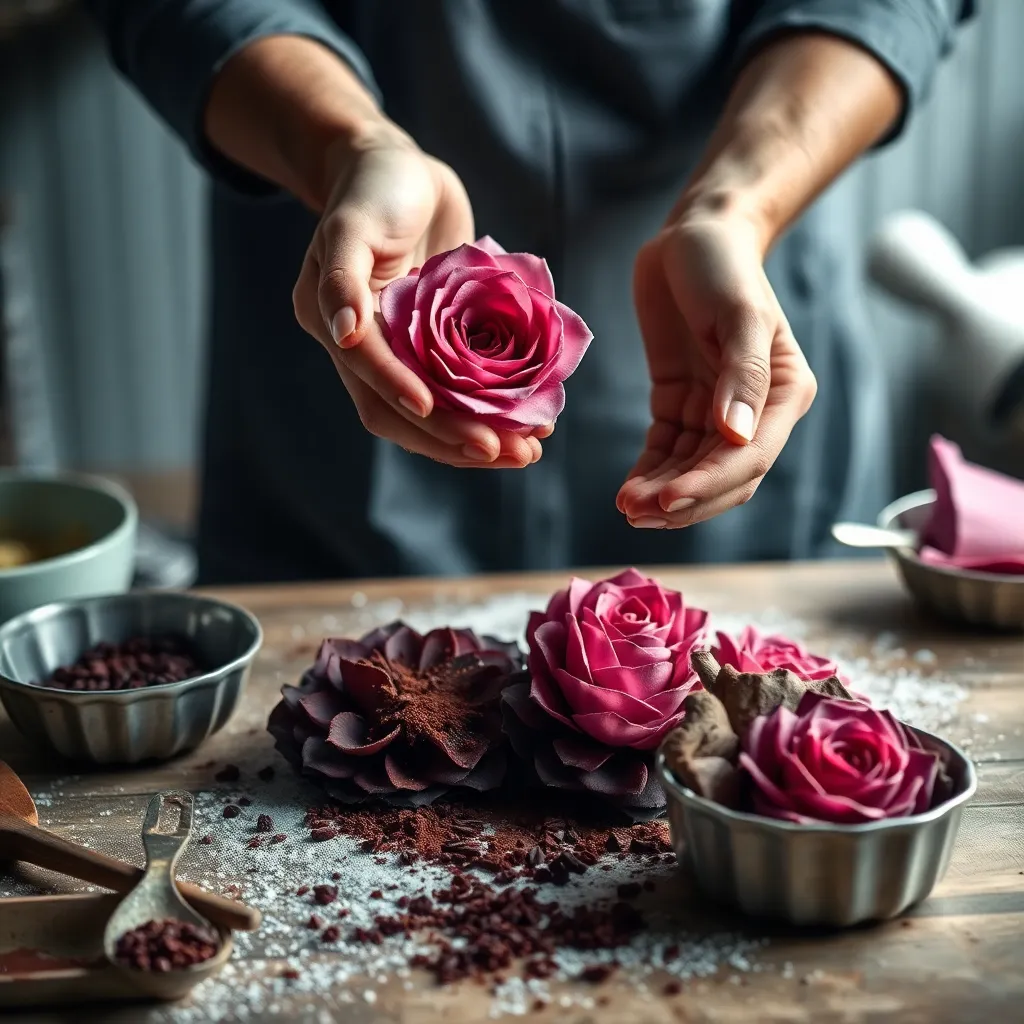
[103, 793, 231, 998]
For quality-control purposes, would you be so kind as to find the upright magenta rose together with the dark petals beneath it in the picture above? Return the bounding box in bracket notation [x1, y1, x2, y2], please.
[502, 569, 708, 813]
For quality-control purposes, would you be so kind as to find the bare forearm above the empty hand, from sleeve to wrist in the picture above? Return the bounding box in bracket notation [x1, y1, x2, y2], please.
[672, 33, 903, 252]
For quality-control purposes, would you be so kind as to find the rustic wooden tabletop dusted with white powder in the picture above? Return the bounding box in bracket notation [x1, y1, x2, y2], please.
[0, 562, 1024, 1024]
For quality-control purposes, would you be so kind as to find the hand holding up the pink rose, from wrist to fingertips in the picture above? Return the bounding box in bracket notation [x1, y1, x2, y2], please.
[293, 125, 551, 469]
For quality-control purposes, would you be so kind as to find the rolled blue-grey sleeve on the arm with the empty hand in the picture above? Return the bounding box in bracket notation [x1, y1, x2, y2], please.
[738, 0, 974, 145]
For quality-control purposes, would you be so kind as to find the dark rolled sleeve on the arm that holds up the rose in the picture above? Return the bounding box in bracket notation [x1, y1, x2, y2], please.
[79, 0, 380, 196]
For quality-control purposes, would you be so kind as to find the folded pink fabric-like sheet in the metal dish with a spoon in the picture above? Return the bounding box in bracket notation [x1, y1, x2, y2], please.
[919, 436, 1024, 574]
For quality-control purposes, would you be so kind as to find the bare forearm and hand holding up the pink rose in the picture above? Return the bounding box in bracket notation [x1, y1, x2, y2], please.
[205, 36, 553, 468]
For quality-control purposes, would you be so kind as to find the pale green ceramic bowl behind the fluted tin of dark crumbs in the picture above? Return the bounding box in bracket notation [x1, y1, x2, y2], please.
[0, 470, 138, 623]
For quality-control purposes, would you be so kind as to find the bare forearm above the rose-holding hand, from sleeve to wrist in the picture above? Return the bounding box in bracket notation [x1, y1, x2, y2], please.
[203, 36, 396, 211]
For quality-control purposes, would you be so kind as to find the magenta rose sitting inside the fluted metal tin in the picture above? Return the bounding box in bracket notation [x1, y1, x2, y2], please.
[739, 690, 939, 824]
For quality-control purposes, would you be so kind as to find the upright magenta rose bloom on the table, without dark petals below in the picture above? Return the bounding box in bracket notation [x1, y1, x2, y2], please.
[526, 569, 708, 751]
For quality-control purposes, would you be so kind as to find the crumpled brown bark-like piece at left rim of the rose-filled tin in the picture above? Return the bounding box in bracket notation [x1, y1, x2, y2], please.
[662, 690, 739, 807]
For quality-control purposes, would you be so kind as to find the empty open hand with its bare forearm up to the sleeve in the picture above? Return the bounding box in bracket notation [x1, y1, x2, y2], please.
[617, 32, 903, 528]
